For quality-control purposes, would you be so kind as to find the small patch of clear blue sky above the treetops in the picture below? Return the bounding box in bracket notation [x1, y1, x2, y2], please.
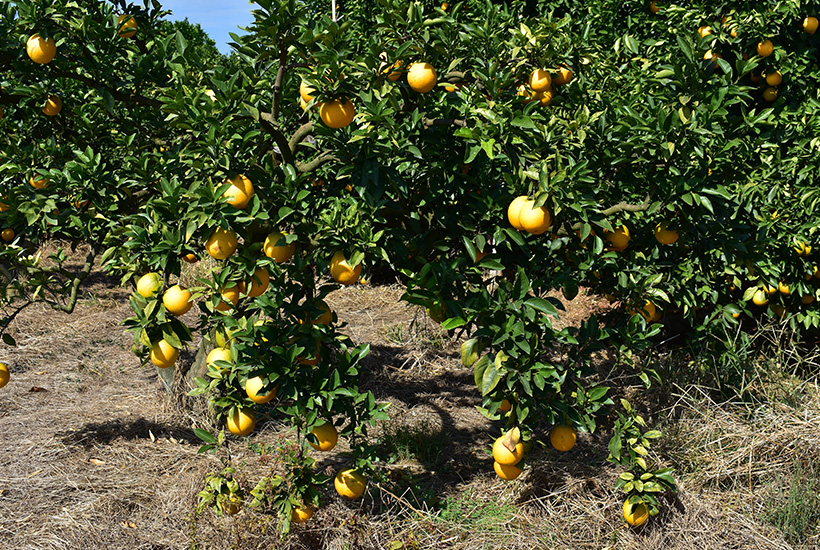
[156, 0, 253, 53]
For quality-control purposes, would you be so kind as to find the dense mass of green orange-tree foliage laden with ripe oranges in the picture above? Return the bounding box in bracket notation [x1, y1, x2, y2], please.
[0, 0, 820, 528]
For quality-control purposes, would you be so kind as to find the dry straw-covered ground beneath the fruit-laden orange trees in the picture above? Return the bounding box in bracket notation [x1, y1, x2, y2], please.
[0, 275, 817, 550]
